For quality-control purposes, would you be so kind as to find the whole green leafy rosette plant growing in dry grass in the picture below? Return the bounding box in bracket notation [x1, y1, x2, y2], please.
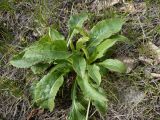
[10, 13, 126, 120]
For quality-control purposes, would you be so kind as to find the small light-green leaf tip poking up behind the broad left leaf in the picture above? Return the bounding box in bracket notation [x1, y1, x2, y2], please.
[49, 28, 65, 41]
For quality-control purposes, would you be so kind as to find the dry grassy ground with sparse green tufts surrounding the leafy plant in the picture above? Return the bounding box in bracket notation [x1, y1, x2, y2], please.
[0, 0, 160, 120]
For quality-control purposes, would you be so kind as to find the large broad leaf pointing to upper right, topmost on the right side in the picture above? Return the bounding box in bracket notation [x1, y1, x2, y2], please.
[89, 18, 125, 47]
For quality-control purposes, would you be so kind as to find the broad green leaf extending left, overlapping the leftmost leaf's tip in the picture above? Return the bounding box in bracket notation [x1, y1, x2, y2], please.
[23, 37, 70, 62]
